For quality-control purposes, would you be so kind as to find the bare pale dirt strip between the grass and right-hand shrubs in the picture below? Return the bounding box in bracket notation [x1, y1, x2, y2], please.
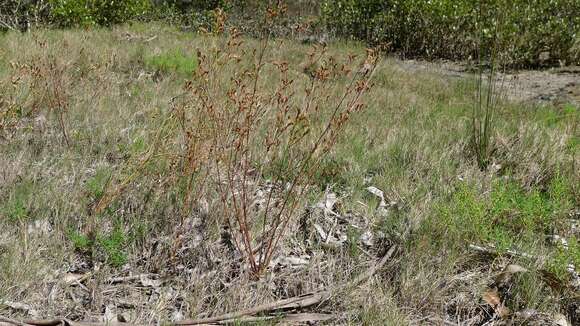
[397, 60, 580, 106]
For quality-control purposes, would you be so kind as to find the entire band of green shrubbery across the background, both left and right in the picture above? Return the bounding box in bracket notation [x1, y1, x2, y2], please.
[0, 0, 580, 66]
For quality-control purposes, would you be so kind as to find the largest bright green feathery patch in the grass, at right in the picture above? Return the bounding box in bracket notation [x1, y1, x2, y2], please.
[422, 177, 574, 252]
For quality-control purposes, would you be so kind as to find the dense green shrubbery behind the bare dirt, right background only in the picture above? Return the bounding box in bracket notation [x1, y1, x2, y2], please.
[322, 0, 580, 65]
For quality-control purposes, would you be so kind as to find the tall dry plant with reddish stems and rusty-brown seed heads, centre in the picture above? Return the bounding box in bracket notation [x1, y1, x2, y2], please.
[174, 7, 379, 277]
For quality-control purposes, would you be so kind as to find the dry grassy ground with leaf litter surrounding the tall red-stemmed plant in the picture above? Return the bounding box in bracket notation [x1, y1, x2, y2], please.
[0, 24, 580, 325]
